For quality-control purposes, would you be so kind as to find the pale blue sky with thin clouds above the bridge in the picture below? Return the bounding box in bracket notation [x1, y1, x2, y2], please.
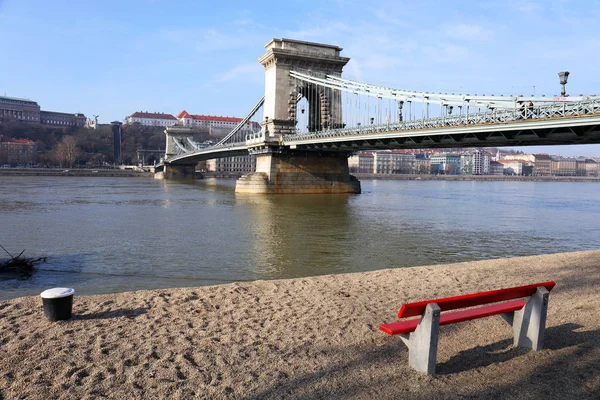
[0, 0, 600, 156]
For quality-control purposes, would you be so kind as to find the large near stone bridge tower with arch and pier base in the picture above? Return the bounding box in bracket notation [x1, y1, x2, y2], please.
[236, 39, 360, 193]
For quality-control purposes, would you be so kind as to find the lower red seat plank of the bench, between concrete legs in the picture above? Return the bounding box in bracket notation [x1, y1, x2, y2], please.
[379, 300, 526, 335]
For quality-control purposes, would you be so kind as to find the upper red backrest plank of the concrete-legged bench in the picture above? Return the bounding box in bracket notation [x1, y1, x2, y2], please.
[398, 281, 556, 318]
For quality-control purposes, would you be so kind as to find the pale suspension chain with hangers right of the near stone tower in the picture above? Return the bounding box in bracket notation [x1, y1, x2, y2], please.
[286, 70, 600, 140]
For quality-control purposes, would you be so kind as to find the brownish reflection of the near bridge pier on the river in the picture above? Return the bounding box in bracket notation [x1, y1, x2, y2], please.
[236, 194, 352, 279]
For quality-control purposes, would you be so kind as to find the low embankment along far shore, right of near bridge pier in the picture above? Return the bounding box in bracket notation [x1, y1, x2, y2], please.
[352, 173, 600, 182]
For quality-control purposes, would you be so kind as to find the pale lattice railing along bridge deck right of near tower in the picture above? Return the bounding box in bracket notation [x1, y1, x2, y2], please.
[283, 98, 600, 144]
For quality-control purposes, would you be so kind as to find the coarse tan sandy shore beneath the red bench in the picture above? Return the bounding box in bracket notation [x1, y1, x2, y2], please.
[0, 251, 600, 399]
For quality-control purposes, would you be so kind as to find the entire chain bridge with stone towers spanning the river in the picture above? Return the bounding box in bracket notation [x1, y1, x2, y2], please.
[157, 39, 600, 193]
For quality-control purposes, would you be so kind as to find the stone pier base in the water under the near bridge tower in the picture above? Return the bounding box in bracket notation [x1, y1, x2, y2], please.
[235, 152, 360, 194]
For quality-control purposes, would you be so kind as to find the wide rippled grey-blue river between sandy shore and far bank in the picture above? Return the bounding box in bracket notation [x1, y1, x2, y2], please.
[0, 177, 600, 300]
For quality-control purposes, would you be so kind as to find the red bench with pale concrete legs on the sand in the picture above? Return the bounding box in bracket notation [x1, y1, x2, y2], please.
[379, 282, 555, 374]
